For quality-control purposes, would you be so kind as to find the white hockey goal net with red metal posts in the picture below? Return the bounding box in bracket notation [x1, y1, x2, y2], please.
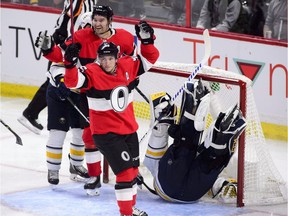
[104, 62, 287, 206]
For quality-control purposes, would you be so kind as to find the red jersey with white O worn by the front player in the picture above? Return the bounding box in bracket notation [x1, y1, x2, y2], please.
[64, 44, 159, 134]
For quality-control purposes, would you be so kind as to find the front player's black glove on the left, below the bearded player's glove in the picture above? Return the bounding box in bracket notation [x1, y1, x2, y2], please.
[64, 43, 82, 68]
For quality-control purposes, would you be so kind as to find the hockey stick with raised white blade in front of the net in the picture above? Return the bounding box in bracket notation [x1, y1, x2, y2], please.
[139, 29, 211, 143]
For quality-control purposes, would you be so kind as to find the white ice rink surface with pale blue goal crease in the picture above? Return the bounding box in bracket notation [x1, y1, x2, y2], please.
[0, 97, 288, 216]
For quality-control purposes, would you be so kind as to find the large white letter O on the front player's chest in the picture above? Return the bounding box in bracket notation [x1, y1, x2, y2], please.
[110, 86, 129, 112]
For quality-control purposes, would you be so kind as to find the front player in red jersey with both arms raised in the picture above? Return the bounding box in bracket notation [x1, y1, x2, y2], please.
[64, 21, 159, 216]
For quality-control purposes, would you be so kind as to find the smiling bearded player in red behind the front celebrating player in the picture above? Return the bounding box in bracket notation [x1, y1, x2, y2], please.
[36, 5, 135, 195]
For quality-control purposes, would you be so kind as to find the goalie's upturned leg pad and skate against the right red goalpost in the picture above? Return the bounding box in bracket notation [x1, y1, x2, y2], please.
[204, 105, 246, 157]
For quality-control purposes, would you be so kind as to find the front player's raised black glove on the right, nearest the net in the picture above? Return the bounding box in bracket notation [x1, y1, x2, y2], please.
[135, 20, 155, 45]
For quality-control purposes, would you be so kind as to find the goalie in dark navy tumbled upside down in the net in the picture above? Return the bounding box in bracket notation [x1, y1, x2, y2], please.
[144, 80, 246, 203]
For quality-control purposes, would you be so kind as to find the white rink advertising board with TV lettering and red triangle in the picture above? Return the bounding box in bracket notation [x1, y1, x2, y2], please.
[1, 7, 288, 126]
